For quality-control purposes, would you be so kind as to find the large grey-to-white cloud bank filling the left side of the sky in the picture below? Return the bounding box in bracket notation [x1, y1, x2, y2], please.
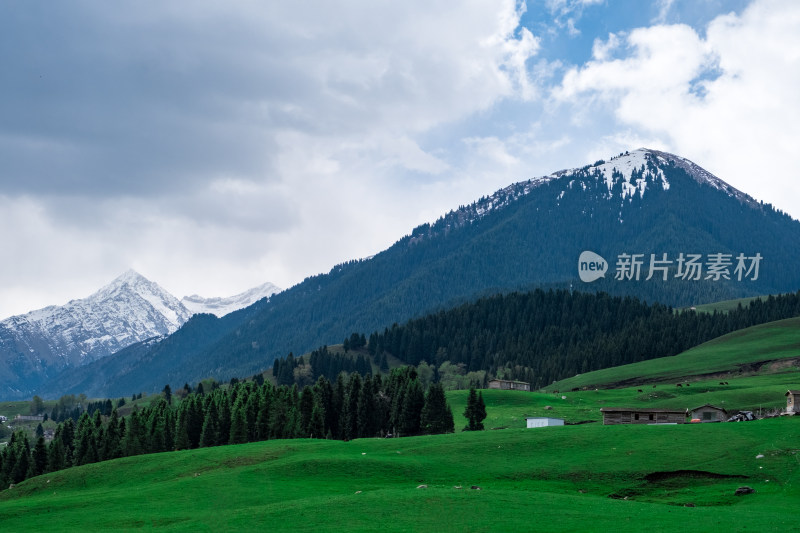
[0, 0, 540, 315]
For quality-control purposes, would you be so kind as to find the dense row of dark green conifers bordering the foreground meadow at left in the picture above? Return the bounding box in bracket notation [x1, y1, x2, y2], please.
[0, 367, 454, 488]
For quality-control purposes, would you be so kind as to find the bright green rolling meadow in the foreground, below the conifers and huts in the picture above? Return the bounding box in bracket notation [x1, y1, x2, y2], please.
[0, 416, 800, 531]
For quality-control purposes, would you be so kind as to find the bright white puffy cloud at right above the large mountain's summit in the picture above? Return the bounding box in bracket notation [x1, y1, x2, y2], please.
[554, 0, 800, 217]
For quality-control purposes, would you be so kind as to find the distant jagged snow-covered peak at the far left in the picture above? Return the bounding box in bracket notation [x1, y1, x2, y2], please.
[0, 270, 191, 397]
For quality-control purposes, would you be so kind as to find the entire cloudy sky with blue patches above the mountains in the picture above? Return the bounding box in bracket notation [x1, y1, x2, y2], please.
[0, 0, 800, 318]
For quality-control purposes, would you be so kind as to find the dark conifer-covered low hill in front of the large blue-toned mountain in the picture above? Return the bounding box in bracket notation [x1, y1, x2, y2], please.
[275, 289, 800, 388]
